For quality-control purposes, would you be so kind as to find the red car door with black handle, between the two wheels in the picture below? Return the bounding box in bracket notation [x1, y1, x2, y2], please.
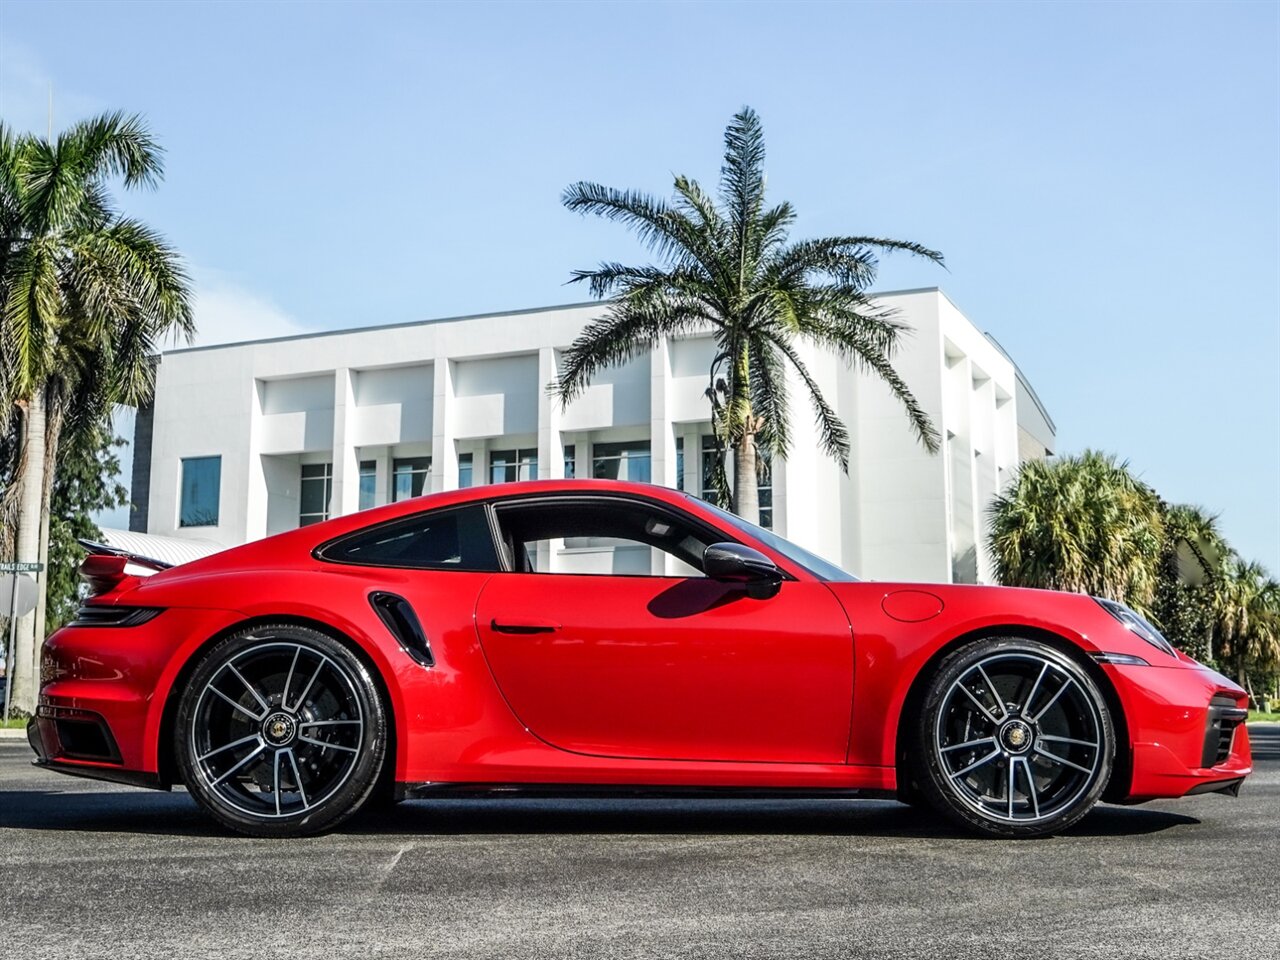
[476, 498, 852, 763]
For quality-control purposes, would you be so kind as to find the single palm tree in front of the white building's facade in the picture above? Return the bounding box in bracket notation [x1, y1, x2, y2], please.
[556, 108, 942, 521]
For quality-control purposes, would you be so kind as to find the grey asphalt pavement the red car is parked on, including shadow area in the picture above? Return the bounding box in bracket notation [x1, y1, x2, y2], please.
[0, 726, 1280, 960]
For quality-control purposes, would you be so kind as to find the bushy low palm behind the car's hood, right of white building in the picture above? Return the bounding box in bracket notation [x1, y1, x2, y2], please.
[988, 451, 1165, 613]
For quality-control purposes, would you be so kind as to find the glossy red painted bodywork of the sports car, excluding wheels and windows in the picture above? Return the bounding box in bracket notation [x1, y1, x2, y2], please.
[32, 481, 1251, 800]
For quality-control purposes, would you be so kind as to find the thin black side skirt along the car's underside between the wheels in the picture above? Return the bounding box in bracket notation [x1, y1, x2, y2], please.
[396, 782, 897, 800]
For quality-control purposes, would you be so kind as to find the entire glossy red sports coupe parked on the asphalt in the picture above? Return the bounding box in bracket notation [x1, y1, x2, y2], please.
[28, 480, 1251, 836]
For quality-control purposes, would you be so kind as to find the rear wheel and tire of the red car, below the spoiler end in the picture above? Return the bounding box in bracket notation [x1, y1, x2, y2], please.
[174, 623, 387, 837]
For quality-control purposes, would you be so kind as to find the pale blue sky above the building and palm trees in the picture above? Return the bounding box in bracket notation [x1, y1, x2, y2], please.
[0, 0, 1280, 572]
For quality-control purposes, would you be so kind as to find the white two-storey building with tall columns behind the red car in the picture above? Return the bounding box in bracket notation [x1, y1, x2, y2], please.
[131, 289, 1053, 581]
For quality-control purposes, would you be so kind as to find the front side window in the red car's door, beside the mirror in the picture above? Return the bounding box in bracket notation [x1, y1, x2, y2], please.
[497, 497, 723, 576]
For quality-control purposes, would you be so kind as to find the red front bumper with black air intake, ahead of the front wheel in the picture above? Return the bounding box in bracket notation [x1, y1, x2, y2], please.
[1105, 666, 1253, 803]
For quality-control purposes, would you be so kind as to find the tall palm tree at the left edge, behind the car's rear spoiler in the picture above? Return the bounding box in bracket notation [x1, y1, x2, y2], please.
[0, 113, 193, 710]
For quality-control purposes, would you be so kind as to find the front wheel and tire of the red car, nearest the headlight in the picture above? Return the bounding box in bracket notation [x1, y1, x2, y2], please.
[910, 637, 1116, 837]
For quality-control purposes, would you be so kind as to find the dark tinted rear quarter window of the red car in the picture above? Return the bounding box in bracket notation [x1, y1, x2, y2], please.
[319, 506, 499, 572]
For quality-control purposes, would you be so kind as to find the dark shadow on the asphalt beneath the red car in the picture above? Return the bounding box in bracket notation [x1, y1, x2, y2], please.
[0, 790, 1199, 842]
